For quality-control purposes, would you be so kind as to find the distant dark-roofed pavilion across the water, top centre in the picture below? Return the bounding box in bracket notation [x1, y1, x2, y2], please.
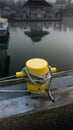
[23, 0, 52, 19]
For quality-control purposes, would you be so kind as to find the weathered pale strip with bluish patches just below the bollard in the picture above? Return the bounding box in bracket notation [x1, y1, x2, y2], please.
[0, 87, 73, 119]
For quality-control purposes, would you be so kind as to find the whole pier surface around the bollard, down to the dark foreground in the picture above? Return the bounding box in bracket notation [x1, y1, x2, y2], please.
[0, 71, 73, 130]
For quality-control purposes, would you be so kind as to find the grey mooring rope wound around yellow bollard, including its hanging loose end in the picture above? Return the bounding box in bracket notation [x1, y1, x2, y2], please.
[0, 66, 54, 101]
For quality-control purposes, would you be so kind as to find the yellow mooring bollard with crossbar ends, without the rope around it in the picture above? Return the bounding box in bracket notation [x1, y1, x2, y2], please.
[16, 58, 57, 94]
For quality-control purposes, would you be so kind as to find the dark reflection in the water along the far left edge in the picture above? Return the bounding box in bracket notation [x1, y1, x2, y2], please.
[0, 34, 10, 77]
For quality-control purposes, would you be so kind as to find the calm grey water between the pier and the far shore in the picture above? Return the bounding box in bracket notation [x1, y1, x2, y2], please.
[0, 19, 73, 77]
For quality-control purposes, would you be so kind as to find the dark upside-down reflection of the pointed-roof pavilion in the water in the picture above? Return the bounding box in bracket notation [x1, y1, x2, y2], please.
[24, 22, 49, 43]
